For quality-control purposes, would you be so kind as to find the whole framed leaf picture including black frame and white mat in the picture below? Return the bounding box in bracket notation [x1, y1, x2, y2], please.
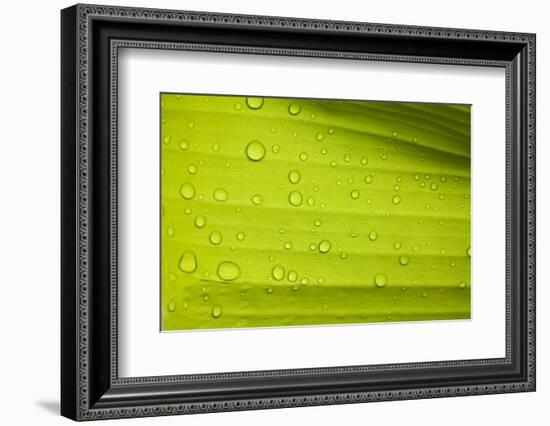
[61, 5, 535, 420]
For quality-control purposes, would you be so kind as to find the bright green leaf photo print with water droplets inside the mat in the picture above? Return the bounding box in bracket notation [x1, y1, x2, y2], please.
[160, 94, 470, 330]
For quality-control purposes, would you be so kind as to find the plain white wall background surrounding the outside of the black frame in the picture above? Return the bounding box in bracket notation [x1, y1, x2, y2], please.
[0, 0, 550, 426]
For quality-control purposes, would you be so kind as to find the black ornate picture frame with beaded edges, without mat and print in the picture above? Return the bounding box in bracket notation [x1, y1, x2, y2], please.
[61, 5, 535, 420]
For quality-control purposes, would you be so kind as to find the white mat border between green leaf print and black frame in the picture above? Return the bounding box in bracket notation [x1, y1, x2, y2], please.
[118, 49, 506, 377]
